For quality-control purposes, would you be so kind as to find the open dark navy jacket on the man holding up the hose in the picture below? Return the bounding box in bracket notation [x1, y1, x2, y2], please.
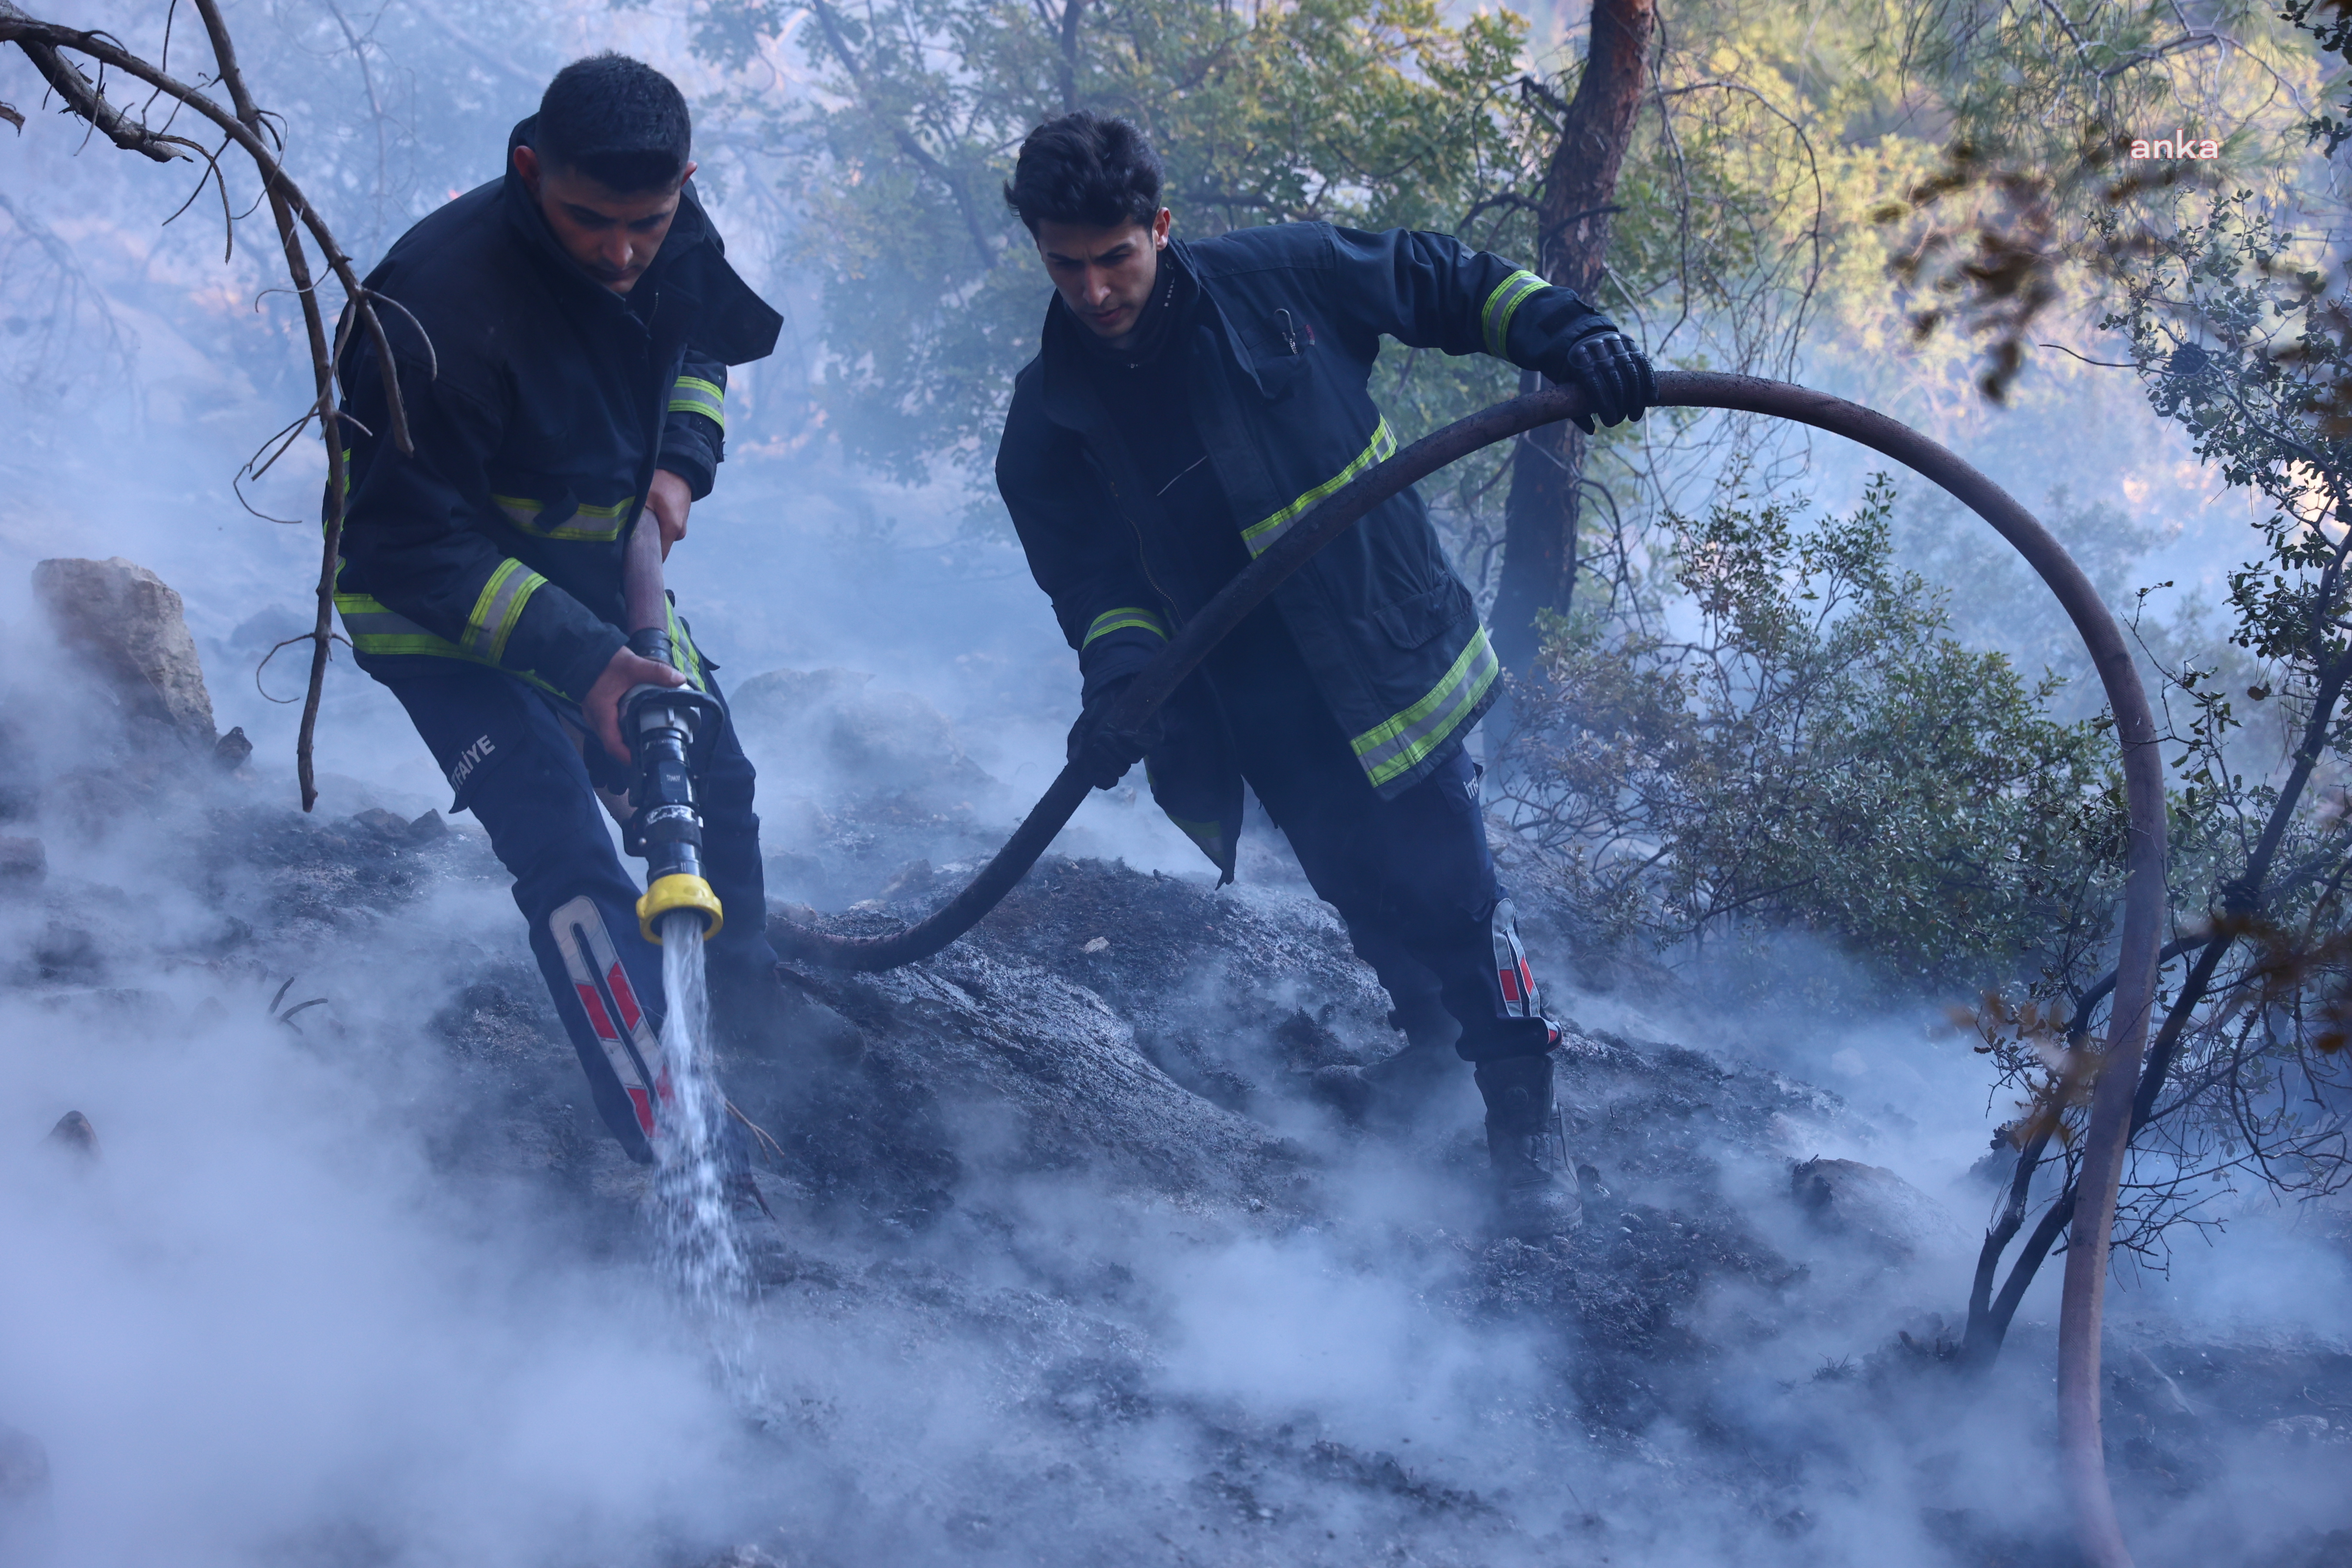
[997, 224, 1611, 879]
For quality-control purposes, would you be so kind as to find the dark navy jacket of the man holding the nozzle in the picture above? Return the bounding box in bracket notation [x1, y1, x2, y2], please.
[334, 120, 783, 703]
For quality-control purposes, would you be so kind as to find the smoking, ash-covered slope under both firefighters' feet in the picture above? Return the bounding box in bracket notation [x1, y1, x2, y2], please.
[0, 564, 2352, 1568]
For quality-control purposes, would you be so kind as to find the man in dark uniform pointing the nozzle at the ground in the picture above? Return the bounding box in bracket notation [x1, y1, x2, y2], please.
[334, 54, 781, 1197]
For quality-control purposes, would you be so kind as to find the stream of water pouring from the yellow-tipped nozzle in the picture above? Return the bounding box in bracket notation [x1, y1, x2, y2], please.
[654, 910, 750, 1309]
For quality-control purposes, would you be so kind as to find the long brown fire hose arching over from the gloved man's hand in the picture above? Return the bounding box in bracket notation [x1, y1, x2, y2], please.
[769, 371, 2164, 1568]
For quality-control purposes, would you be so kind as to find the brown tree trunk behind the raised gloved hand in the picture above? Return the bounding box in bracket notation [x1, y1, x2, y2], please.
[1491, 0, 1658, 675]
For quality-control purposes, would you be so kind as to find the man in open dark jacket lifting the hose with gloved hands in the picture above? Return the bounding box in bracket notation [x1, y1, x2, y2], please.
[997, 113, 1656, 1234]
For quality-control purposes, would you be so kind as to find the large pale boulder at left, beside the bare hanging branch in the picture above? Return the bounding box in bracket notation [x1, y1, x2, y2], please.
[33, 555, 216, 752]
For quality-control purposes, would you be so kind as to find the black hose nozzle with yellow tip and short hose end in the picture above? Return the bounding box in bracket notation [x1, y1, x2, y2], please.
[621, 508, 727, 943]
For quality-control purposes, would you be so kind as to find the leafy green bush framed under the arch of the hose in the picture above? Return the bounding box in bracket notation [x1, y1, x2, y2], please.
[1508, 477, 2119, 990]
